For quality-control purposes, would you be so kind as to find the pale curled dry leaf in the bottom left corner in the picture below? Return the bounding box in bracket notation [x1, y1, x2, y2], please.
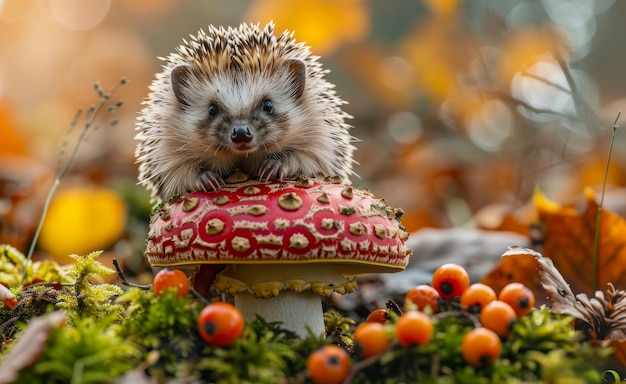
[0, 312, 67, 384]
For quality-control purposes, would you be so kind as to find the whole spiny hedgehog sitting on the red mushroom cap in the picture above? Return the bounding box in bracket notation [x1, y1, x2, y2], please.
[135, 22, 355, 202]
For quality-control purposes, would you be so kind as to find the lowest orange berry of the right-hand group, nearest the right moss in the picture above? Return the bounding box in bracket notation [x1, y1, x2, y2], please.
[461, 328, 502, 367]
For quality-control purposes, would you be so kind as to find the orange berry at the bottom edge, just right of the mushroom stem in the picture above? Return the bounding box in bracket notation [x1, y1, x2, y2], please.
[306, 344, 350, 384]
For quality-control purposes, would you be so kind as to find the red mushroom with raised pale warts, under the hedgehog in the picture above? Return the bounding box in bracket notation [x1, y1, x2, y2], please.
[145, 178, 411, 336]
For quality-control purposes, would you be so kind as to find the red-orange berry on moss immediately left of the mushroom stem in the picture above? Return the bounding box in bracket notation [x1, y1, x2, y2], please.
[198, 302, 244, 347]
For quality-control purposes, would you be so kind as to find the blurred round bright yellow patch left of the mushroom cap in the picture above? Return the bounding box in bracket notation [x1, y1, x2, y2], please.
[39, 187, 126, 264]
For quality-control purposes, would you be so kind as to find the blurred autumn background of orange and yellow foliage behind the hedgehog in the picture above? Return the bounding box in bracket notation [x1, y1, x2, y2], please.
[0, 0, 626, 282]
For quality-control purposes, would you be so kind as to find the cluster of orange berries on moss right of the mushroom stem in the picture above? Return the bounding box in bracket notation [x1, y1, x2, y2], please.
[307, 264, 535, 383]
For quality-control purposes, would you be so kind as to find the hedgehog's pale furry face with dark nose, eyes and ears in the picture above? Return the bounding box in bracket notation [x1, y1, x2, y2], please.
[171, 60, 306, 156]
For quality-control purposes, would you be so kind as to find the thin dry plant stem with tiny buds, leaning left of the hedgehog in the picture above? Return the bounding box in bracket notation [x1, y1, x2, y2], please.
[20, 78, 126, 285]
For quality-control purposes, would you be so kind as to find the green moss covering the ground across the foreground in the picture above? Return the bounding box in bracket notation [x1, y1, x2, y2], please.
[0, 247, 610, 384]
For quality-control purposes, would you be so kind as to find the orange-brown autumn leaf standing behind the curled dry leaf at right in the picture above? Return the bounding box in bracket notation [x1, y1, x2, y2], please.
[482, 189, 626, 303]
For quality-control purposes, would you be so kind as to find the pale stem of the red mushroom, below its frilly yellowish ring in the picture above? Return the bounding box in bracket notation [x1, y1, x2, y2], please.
[235, 290, 324, 337]
